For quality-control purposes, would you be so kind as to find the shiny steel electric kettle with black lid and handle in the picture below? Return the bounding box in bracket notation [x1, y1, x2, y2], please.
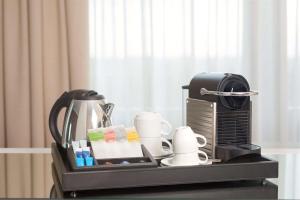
[49, 90, 114, 148]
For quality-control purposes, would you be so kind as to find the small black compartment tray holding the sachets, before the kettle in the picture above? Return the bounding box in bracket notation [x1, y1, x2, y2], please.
[67, 145, 157, 172]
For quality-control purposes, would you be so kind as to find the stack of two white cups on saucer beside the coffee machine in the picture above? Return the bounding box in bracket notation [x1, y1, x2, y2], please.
[172, 126, 208, 165]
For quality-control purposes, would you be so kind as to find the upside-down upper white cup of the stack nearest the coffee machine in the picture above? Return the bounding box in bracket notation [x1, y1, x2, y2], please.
[172, 126, 207, 154]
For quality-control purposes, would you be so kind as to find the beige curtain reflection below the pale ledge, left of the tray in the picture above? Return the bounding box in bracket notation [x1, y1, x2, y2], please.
[0, 154, 53, 198]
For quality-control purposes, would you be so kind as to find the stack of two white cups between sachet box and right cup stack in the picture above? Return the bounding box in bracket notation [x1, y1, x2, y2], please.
[134, 112, 173, 157]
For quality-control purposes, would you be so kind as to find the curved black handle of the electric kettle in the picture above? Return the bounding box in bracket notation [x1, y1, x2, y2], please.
[49, 92, 70, 146]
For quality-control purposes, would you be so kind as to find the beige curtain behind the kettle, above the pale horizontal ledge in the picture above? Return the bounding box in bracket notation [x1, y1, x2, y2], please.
[0, 0, 89, 147]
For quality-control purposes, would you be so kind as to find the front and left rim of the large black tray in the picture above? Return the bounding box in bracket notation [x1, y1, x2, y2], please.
[51, 143, 278, 191]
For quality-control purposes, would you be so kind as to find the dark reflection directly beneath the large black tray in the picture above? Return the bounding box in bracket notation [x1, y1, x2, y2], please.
[50, 163, 278, 200]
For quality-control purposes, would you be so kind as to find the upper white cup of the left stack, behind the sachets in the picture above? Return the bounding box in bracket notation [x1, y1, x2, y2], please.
[134, 112, 172, 138]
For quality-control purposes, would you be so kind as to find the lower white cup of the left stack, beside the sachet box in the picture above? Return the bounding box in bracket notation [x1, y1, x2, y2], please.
[141, 137, 173, 157]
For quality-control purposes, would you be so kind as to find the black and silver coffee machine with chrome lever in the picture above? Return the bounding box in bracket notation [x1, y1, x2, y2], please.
[183, 73, 260, 161]
